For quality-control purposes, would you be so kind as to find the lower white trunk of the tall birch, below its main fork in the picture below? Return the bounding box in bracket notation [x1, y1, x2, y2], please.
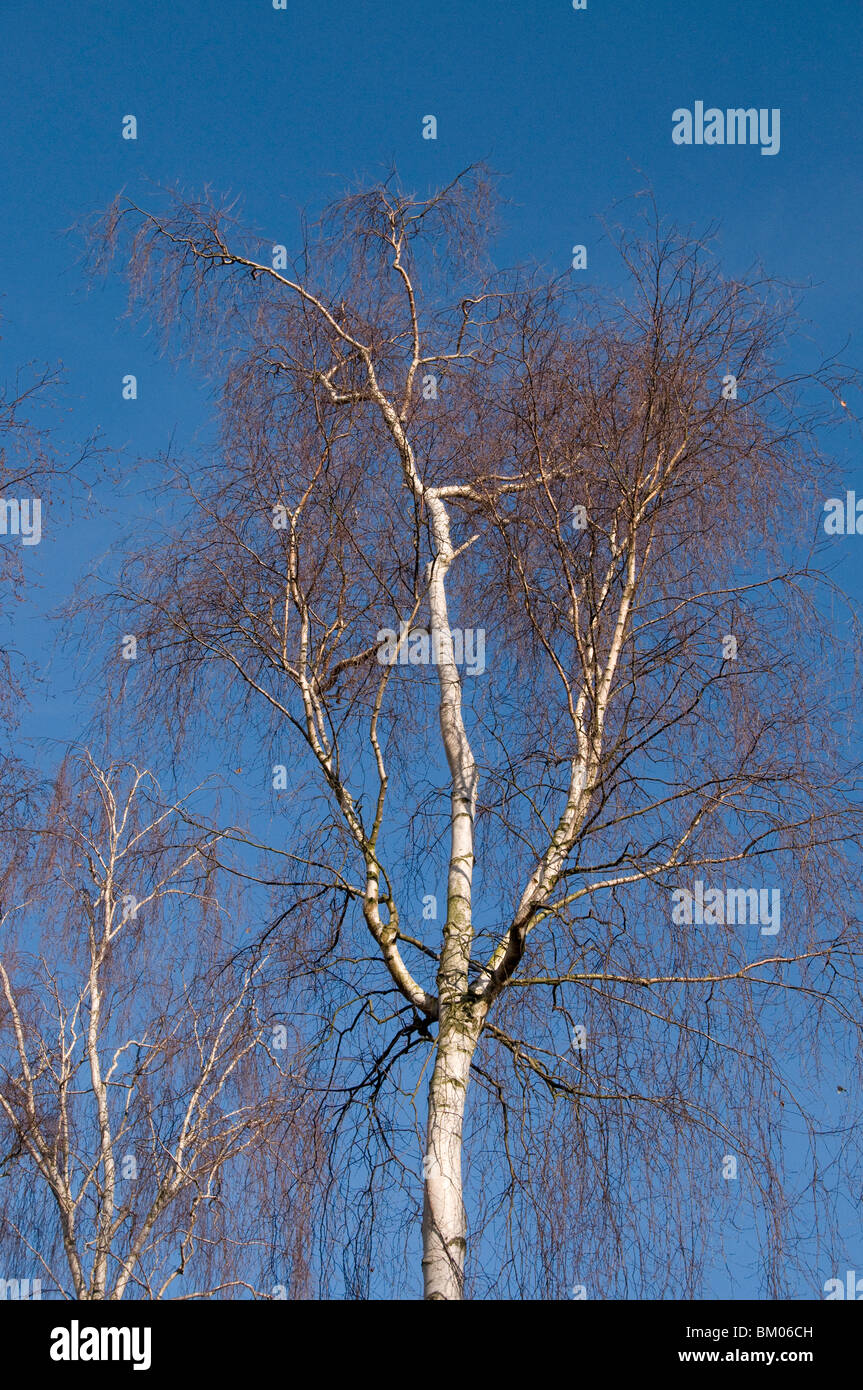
[422, 1019, 478, 1298]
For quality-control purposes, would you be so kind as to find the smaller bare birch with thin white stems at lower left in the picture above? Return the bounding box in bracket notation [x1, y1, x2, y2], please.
[0, 755, 316, 1300]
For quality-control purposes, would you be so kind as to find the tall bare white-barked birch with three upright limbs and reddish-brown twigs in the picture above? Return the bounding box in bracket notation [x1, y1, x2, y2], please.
[96, 171, 860, 1300]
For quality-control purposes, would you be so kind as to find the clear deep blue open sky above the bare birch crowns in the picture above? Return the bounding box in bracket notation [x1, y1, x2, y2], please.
[0, 0, 863, 1301]
